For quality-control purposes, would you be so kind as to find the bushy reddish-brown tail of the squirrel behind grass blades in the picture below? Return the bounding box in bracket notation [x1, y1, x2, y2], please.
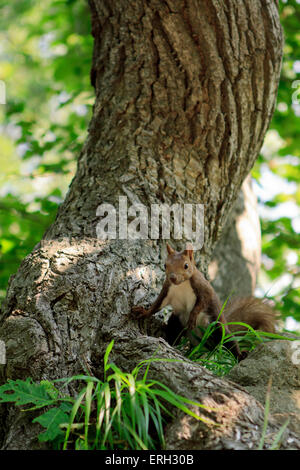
[224, 297, 277, 333]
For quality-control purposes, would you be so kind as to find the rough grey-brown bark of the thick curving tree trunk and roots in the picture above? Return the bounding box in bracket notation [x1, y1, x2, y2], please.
[0, 0, 299, 449]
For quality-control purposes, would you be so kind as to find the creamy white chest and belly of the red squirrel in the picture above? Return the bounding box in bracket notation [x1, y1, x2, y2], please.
[161, 281, 196, 326]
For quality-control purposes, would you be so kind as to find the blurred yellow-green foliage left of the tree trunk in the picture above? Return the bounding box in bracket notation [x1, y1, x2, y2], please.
[0, 0, 94, 299]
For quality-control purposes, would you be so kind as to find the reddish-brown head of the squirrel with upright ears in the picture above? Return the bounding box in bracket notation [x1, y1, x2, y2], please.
[165, 243, 196, 285]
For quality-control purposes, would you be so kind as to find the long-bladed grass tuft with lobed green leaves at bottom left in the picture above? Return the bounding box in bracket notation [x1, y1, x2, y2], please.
[0, 342, 212, 450]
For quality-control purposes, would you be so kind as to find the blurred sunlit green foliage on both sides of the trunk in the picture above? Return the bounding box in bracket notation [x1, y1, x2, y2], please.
[0, 0, 300, 329]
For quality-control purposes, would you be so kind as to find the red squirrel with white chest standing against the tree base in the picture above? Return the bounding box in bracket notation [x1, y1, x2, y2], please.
[132, 243, 275, 360]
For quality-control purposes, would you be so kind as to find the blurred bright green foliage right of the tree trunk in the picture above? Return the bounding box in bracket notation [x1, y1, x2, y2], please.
[253, 0, 300, 322]
